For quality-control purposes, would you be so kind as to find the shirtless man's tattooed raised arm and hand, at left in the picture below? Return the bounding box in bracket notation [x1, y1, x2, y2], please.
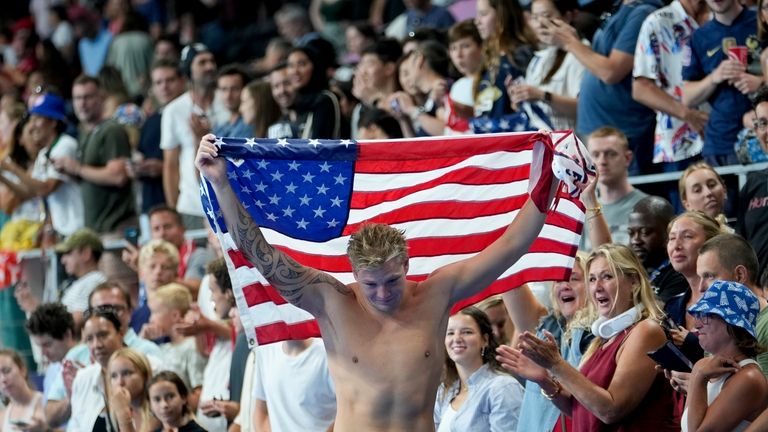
[195, 134, 349, 317]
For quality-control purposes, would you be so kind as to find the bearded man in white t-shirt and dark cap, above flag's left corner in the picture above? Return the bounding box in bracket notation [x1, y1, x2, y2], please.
[160, 43, 229, 229]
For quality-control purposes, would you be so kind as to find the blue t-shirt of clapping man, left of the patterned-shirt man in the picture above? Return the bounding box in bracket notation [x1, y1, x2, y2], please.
[576, 0, 662, 139]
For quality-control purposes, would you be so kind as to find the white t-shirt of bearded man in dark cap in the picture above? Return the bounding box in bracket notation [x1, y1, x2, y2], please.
[160, 92, 229, 216]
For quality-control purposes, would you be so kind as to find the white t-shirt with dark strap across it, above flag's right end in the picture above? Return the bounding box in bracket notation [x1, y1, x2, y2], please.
[525, 46, 584, 130]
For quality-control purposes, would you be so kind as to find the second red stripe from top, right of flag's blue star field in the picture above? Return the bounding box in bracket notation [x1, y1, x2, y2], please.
[349, 165, 531, 209]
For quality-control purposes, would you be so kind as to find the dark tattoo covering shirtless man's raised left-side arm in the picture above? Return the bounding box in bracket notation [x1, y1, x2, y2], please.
[231, 202, 350, 305]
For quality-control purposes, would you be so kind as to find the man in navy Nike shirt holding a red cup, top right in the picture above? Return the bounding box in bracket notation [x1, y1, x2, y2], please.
[683, 0, 764, 167]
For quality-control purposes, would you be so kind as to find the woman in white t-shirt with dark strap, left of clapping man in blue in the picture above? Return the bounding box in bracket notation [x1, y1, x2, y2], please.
[506, 0, 584, 130]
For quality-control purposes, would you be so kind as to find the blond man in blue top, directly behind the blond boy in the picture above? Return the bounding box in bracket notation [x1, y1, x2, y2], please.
[130, 240, 179, 339]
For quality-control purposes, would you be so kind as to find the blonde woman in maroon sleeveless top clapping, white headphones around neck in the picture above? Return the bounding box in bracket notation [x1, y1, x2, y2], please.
[518, 244, 680, 432]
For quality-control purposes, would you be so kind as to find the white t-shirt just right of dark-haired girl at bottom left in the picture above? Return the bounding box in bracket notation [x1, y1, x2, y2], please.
[196, 339, 232, 432]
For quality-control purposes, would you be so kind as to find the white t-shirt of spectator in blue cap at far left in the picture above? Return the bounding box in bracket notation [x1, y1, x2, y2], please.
[32, 134, 85, 236]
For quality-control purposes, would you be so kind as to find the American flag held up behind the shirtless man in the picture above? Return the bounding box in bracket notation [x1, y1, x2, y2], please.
[201, 133, 584, 345]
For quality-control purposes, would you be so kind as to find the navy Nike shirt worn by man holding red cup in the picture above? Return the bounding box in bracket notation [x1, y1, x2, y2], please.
[683, 8, 764, 156]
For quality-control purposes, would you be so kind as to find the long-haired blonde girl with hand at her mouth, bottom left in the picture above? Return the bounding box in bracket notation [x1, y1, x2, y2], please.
[106, 348, 160, 432]
